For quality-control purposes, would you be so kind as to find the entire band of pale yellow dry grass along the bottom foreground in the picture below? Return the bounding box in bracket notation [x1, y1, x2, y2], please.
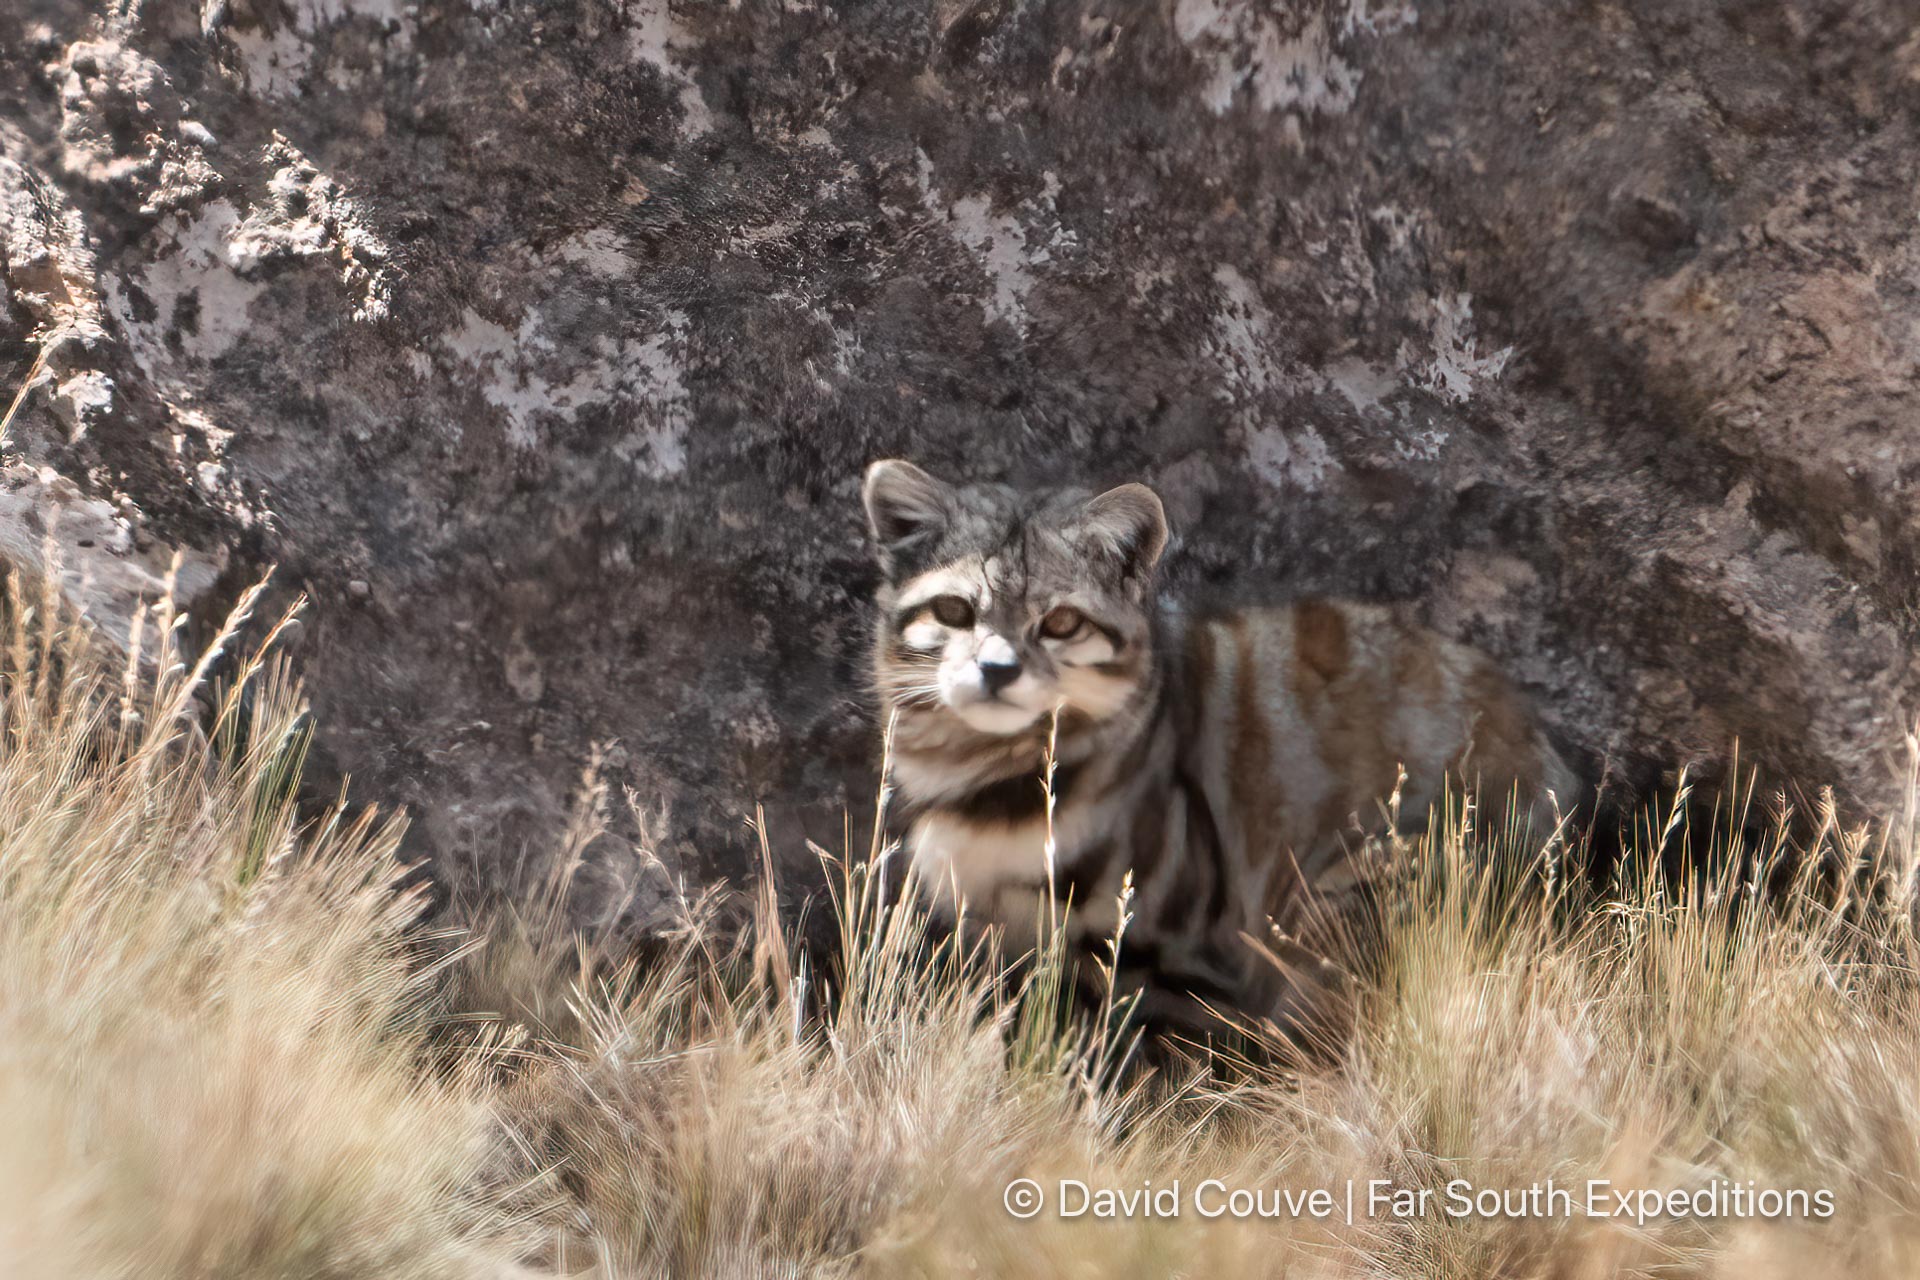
[0, 575, 1920, 1280]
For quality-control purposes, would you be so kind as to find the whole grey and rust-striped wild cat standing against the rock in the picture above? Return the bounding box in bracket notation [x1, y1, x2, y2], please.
[864, 461, 1574, 1025]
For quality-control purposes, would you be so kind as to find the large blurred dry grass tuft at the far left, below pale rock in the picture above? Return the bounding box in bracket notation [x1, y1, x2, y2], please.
[0, 571, 522, 1276]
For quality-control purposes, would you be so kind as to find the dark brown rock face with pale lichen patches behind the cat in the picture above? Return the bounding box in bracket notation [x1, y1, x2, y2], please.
[0, 0, 1920, 921]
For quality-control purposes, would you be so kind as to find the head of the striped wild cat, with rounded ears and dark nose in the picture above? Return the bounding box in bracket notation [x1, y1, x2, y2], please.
[864, 461, 1167, 737]
